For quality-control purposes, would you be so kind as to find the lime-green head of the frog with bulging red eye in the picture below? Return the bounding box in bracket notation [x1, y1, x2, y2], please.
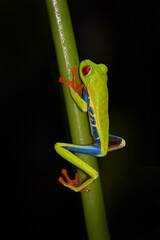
[79, 60, 108, 86]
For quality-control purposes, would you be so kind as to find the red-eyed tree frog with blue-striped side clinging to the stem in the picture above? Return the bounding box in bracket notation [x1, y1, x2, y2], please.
[55, 60, 126, 192]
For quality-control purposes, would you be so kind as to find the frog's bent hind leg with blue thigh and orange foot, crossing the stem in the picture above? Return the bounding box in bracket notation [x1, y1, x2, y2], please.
[55, 143, 100, 192]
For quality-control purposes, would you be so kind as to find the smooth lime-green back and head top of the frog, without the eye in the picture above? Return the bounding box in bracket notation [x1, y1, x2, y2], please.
[80, 60, 109, 156]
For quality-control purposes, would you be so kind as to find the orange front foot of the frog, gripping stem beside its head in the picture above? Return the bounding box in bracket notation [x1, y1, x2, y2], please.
[59, 68, 84, 96]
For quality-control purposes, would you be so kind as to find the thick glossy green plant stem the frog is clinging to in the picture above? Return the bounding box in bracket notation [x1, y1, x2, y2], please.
[46, 0, 110, 240]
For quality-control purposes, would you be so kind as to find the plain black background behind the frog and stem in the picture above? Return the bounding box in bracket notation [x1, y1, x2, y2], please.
[0, 0, 160, 240]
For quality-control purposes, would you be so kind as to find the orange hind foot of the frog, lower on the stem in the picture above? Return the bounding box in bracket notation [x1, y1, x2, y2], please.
[59, 169, 91, 192]
